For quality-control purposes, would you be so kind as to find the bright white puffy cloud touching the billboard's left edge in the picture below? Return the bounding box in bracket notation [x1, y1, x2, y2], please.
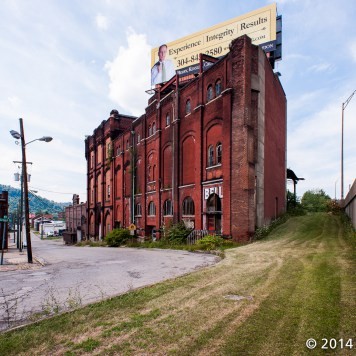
[105, 28, 151, 116]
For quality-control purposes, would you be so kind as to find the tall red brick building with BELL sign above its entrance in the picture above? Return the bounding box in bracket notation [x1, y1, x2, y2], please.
[85, 36, 286, 240]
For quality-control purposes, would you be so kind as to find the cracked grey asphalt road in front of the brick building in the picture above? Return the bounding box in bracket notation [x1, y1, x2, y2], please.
[0, 234, 218, 329]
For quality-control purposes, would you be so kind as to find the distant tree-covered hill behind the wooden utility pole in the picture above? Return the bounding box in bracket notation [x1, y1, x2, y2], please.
[0, 184, 71, 214]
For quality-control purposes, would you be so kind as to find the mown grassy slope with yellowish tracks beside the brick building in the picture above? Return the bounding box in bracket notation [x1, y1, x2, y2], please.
[0, 213, 356, 355]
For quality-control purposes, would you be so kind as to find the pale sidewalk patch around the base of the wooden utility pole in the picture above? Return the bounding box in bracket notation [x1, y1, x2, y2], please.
[0, 235, 43, 273]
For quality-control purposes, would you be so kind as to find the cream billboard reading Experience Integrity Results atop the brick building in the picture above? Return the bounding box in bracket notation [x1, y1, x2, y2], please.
[151, 3, 277, 85]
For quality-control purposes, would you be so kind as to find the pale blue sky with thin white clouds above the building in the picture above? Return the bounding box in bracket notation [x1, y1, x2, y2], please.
[0, 0, 356, 202]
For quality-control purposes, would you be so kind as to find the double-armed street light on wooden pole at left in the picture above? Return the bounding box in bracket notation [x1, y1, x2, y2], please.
[10, 118, 52, 263]
